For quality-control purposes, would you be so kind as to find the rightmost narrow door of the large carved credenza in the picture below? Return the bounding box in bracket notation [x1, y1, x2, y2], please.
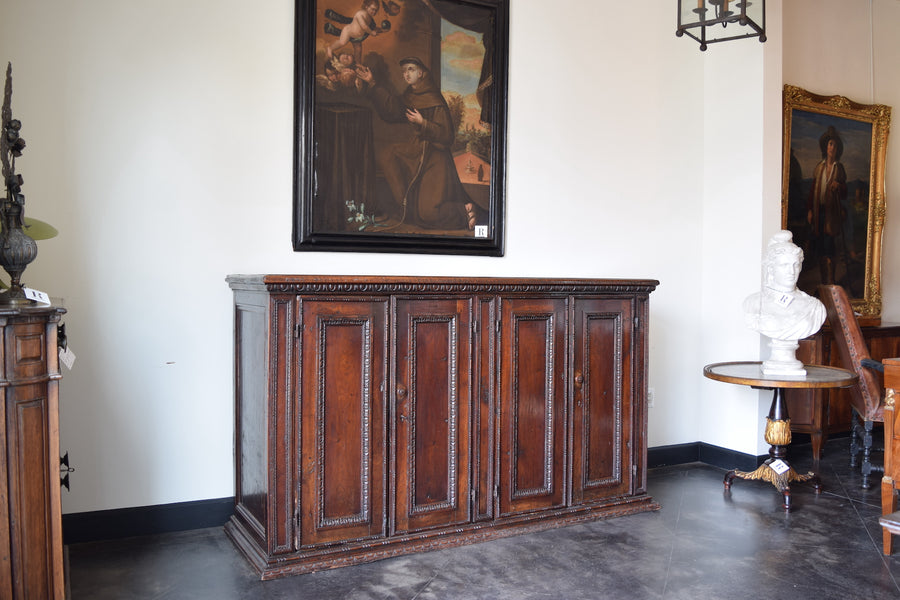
[572, 298, 634, 504]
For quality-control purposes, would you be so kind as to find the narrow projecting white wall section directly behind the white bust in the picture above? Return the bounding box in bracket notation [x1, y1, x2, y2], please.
[697, 1, 781, 454]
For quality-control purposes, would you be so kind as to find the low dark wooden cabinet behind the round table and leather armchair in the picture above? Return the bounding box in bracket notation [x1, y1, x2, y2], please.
[786, 323, 900, 458]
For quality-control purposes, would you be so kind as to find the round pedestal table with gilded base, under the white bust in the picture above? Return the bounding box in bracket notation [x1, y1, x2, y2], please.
[703, 362, 858, 510]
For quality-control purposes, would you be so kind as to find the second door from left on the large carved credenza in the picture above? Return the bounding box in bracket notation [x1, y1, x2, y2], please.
[392, 298, 473, 532]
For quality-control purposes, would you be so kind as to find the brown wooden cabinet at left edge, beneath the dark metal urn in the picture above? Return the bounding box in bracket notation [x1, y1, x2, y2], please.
[0, 307, 65, 600]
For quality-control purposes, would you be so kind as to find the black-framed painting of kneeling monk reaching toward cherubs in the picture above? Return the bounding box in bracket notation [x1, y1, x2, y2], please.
[293, 0, 509, 256]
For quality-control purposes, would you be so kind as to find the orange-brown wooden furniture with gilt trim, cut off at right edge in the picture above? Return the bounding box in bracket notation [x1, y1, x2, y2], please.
[879, 358, 900, 556]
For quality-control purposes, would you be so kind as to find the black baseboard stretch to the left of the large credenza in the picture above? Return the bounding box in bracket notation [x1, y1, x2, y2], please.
[63, 498, 234, 544]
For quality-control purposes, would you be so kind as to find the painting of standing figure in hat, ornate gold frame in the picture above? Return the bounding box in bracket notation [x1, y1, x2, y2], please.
[781, 85, 891, 322]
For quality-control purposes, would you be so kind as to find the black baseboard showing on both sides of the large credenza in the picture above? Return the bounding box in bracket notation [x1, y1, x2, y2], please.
[62, 442, 768, 544]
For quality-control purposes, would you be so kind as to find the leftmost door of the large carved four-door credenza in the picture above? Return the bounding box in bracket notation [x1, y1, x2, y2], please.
[298, 299, 388, 546]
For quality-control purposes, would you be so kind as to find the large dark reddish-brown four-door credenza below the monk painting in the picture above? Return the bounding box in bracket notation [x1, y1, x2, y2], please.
[226, 275, 658, 579]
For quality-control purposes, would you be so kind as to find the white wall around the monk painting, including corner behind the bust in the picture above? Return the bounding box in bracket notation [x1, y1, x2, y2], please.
[0, 0, 888, 513]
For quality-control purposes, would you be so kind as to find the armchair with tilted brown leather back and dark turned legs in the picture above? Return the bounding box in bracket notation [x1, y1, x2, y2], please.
[819, 285, 884, 489]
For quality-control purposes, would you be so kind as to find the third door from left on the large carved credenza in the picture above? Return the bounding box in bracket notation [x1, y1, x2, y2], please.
[499, 298, 567, 515]
